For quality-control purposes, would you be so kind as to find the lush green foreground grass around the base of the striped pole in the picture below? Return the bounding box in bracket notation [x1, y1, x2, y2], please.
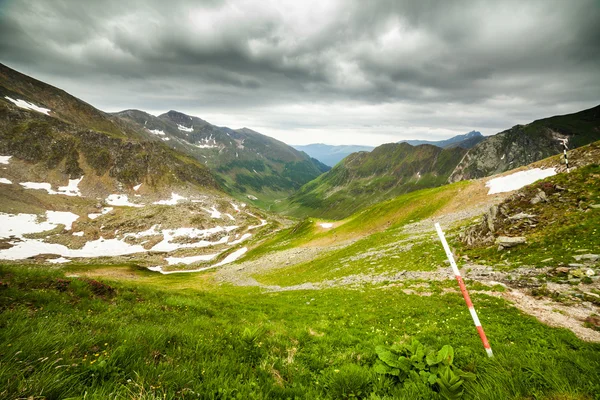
[0, 266, 600, 399]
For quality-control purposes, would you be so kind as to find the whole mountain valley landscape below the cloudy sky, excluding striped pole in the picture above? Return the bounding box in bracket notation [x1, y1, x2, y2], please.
[0, 66, 600, 399]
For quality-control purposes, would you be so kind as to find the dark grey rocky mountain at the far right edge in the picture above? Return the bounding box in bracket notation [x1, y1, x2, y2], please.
[449, 106, 600, 182]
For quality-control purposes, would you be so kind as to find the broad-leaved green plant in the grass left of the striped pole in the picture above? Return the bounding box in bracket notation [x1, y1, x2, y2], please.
[375, 340, 475, 399]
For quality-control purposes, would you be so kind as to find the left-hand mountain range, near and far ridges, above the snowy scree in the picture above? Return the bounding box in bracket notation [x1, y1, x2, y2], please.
[0, 64, 329, 208]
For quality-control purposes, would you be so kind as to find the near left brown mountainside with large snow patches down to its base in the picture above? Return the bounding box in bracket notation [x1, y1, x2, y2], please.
[0, 66, 274, 276]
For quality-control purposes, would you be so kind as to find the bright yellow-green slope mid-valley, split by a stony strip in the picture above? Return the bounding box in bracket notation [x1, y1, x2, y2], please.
[247, 182, 472, 285]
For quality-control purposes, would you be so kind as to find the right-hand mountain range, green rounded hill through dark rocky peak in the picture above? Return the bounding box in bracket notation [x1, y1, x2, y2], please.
[286, 106, 600, 219]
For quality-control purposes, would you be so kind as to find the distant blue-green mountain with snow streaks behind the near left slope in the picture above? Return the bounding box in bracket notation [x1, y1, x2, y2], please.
[113, 110, 329, 205]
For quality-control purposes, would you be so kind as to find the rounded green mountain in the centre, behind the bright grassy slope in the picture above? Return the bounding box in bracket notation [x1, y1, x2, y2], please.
[289, 143, 467, 219]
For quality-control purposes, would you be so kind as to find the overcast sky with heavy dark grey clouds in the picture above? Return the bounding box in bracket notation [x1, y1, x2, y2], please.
[0, 0, 600, 145]
